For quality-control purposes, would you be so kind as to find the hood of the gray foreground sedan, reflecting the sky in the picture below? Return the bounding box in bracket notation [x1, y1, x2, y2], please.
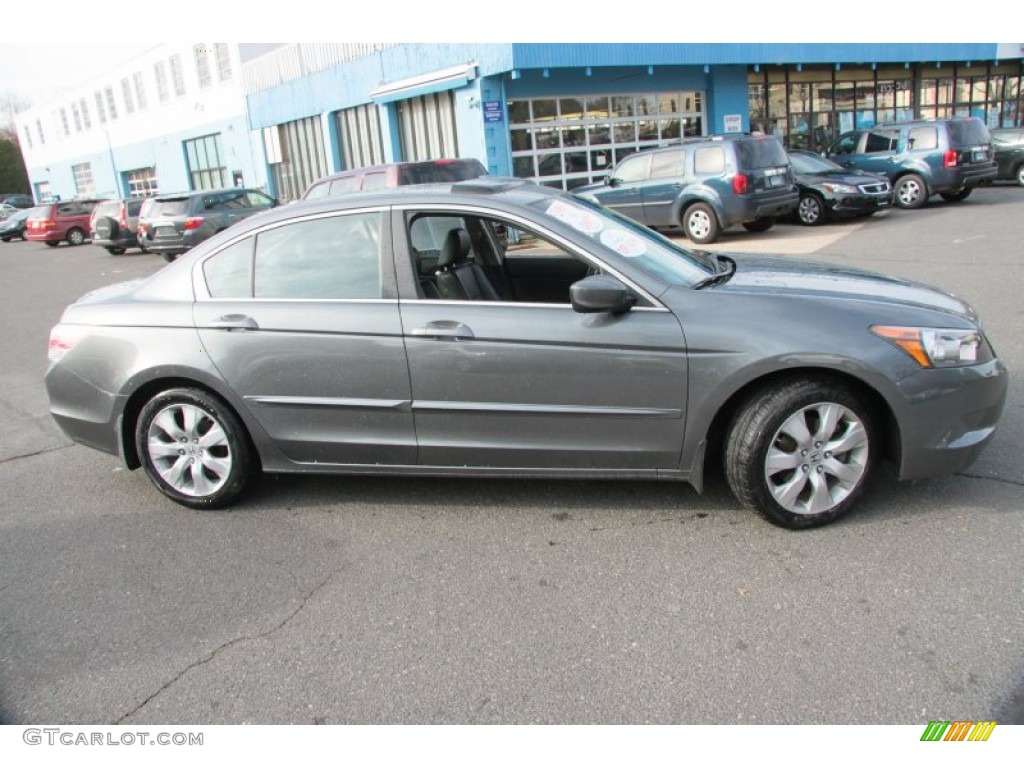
[714, 253, 978, 323]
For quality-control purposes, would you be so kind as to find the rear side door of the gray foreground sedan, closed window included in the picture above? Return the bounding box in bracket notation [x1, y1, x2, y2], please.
[194, 208, 416, 468]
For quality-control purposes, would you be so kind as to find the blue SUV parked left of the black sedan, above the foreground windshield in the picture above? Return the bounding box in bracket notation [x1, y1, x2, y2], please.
[572, 134, 800, 244]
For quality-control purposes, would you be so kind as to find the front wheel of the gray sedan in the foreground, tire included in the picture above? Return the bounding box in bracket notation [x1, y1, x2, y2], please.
[725, 379, 879, 528]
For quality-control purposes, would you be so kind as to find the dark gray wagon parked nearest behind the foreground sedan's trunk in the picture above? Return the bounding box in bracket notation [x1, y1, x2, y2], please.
[138, 186, 278, 261]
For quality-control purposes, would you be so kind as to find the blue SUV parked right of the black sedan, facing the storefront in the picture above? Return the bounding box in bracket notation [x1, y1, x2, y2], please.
[826, 118, 995, 208]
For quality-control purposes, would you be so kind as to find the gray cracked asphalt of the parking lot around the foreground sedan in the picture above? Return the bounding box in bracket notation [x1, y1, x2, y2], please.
[0, 185, 1024, 724]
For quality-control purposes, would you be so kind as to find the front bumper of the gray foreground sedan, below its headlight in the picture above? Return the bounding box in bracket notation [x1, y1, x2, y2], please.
[897, 358, 1010, 480]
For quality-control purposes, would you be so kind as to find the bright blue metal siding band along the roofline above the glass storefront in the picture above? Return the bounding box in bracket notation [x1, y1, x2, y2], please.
[512, 43, 998, 69]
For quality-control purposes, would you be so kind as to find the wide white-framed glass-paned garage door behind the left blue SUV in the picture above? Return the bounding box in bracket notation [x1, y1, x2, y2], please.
[508, 91, 706, 189]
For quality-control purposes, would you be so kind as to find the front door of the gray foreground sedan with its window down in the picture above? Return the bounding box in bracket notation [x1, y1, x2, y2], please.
[393, 211, 687, 471]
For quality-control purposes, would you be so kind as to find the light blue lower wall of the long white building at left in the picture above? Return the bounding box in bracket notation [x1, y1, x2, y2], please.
[28, 116, 262, 200]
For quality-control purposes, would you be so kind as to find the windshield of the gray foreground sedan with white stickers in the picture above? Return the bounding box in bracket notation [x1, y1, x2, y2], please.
[531, 198, 716, 287]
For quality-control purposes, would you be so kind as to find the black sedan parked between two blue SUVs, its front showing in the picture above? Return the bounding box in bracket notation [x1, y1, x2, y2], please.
[786, 150, 893, 226]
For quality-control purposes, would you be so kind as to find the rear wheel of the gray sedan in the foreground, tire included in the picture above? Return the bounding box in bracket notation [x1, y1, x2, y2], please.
[135, 388, 258, 509]
